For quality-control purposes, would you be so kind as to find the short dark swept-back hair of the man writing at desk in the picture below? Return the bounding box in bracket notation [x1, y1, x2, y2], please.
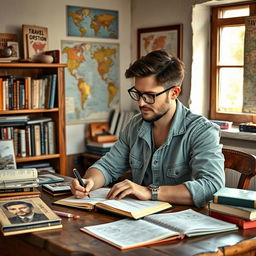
[125, 50, 185, 87]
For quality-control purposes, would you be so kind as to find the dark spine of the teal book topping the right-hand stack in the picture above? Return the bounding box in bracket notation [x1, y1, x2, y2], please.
[213, 196, 256, 208]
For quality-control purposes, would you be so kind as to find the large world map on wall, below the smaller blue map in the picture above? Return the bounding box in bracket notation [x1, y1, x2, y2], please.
[61, 41, 119, 122]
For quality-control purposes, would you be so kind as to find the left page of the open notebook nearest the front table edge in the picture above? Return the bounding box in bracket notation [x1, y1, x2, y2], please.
[81, 219, 179, 248]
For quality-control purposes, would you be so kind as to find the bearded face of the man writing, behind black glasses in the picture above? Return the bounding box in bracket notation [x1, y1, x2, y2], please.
[135, 76, 171, 122]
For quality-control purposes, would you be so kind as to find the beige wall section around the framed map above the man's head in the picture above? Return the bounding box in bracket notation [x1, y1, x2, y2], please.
[132, 0, 192, 106]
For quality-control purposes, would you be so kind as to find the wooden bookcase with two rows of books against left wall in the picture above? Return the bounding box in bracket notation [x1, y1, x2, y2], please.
[0, 63, 67, 175]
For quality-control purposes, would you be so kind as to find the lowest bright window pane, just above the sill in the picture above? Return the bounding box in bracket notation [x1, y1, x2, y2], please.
[218, 68, 243, 112]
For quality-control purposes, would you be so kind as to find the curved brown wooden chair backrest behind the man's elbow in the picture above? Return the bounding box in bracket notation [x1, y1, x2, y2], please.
[222, 148, 256, 189]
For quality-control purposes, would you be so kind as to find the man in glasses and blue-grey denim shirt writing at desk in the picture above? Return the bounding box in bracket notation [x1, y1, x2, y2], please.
[71, 50, 225, 207]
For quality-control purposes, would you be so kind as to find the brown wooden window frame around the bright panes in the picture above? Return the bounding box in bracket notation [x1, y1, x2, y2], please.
[210, 2, 256, 124]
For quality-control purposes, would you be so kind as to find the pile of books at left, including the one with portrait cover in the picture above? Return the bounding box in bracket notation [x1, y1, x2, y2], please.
[0, 168, 62, 236]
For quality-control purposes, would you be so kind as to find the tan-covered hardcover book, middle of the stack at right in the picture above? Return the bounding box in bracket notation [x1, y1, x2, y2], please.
[209, 202, 256, 220]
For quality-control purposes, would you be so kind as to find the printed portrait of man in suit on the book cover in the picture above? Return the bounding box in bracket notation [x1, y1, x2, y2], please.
[3, 201, 48, 224]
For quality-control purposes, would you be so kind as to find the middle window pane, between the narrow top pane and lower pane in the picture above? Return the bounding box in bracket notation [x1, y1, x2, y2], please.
[219, 26, 245, 65]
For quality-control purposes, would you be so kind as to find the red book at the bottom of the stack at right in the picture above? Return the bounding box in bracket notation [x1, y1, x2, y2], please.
[209, 211, 256, 229]
